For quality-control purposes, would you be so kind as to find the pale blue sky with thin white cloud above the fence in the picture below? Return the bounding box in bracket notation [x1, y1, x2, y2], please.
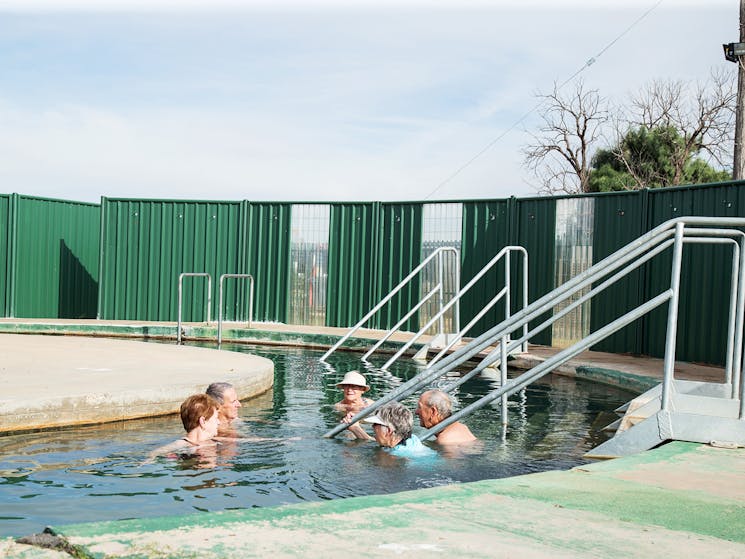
[0, 0, 739, 202]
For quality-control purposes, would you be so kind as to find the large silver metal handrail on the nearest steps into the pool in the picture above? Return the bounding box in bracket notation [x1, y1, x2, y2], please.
[324, 217, 745, 438]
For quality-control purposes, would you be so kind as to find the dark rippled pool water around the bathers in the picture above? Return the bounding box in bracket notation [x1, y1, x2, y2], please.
[0, 346, 632, 536]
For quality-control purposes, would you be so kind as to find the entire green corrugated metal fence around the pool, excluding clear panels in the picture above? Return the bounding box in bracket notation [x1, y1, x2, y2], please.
[0, 182, 745, 363]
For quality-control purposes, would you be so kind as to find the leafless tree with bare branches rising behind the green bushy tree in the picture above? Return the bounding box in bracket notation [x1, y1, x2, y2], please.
[616, 70, 737, 187]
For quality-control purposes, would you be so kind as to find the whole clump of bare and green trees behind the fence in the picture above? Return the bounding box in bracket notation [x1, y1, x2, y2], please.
[524, 71, 736, 194]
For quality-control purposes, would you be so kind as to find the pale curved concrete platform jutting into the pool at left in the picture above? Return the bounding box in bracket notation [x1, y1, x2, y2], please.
[0, 334, 274, 433]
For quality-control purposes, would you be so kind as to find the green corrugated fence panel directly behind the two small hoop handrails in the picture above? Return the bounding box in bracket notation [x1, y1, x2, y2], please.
[99, 199, 242, 322]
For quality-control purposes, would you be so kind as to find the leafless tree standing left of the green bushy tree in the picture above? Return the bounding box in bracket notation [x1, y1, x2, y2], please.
[523, 80, 608, 194]
